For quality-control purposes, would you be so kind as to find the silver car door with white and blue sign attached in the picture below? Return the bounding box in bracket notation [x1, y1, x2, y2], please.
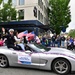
[11, 51, 40, 67]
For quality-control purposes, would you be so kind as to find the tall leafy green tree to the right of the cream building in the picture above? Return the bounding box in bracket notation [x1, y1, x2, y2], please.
[48, 0, 71, 34]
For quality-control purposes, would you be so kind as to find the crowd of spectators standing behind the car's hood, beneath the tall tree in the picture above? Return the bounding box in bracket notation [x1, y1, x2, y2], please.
[41, 34, 75, 50]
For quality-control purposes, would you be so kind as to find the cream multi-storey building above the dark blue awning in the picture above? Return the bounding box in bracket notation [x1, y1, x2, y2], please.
[0, 0, 49, 35]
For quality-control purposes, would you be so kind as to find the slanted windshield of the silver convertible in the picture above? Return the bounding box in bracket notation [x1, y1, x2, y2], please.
[31, 43, 50, 52]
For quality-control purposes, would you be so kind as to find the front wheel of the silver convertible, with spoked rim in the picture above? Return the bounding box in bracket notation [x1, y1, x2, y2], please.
[52, 59, 71, 75]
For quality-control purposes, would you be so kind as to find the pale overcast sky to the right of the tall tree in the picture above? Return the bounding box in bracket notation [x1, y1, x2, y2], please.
[66, 0, 75, 32]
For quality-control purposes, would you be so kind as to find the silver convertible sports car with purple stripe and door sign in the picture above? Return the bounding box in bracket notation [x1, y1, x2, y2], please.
[0, 43, 75, 75]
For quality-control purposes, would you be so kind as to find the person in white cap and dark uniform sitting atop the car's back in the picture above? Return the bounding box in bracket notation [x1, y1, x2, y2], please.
[5, 29, 17, 50]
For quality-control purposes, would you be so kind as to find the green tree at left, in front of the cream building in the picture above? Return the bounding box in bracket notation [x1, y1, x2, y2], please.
[0, 0, 17, 22]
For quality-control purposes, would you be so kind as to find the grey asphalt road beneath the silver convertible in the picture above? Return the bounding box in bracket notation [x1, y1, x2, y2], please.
[0, 67, 75, 75]
